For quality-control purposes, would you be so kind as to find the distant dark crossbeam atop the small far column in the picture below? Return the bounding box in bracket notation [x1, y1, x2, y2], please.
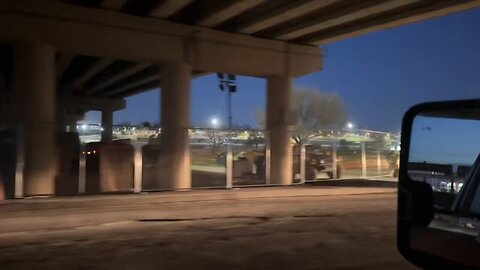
[58, 96, 127, 111]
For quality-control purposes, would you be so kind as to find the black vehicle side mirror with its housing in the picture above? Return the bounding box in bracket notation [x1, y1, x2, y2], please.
[397, 100, 480, 269]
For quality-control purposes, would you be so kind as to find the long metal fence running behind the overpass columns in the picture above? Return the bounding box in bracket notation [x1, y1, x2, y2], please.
[2, 126, 399, 197]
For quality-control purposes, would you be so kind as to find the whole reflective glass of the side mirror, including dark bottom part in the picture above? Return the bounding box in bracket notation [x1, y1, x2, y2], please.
[407, 110, 480, 267]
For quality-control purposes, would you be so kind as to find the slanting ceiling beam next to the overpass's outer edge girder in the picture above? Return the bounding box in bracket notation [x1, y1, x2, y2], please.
[273, 0, 419, 40]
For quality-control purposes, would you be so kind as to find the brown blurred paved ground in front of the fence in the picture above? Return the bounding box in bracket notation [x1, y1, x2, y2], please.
[0, 186, 415, 270]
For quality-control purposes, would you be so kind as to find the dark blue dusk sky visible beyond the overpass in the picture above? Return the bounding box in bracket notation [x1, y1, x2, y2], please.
[88, 9, 480, 131]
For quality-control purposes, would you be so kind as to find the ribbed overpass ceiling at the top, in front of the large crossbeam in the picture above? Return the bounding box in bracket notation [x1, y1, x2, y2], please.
[63, 0, 480, 45]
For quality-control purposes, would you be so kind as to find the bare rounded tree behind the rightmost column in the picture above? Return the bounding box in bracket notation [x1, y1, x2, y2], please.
[257, 89, 347, 144]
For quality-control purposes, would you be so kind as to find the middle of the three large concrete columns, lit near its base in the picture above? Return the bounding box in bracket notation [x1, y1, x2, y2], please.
[160, 62, 192, 190]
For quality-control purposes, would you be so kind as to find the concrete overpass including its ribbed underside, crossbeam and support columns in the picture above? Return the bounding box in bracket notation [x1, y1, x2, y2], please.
[0, 0, 480, 197]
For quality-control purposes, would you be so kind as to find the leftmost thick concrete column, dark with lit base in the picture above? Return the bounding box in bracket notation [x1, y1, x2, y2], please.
[13, 43, 57, 196]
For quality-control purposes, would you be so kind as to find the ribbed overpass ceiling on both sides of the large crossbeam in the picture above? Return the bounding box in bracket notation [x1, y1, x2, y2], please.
[6, 0, 480, 98]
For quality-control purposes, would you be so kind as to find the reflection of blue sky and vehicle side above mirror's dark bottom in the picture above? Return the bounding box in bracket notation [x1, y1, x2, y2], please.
[408, 112, 480, 246]
